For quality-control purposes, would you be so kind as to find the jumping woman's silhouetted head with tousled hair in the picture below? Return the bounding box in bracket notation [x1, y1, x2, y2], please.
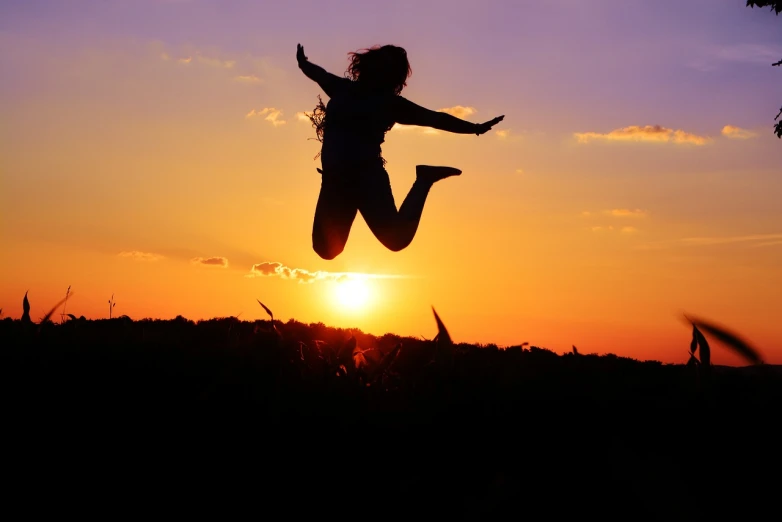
[347, 45, 413, 94]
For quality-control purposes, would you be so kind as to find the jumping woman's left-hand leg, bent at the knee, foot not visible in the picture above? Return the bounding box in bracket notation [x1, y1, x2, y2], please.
[312, 170, 358, 260]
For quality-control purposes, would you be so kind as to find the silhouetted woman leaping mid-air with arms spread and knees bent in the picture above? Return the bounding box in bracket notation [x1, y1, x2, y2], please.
[296, 44, 504, 259]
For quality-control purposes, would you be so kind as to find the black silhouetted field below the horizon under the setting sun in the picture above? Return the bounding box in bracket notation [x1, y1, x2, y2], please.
[0, 312, 782, 520]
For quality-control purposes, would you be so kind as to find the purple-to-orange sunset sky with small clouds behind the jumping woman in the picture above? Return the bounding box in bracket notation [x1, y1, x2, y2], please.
[0, 0, 782, 364]
